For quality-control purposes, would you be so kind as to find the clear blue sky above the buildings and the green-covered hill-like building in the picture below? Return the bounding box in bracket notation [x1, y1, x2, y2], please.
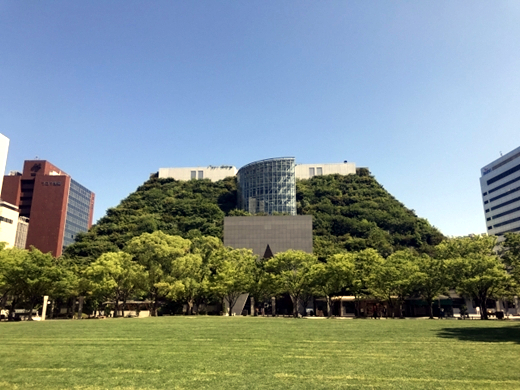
[0, 0, 520, 235]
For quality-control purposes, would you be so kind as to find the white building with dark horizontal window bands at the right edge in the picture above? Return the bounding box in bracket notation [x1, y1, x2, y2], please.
[480, 147, 520, 237]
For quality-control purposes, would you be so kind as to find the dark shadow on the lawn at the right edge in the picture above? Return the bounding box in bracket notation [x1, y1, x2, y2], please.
[437, 325, 520, 344]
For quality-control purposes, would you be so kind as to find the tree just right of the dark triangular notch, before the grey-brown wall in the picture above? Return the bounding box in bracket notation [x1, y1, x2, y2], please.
[265, 250, 318, 317]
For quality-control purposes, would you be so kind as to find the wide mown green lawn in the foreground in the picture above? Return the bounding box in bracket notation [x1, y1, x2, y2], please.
[0, 317, 520, 389]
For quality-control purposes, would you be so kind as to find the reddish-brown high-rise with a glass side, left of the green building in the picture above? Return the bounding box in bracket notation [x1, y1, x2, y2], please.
[2, 160, 94, 256]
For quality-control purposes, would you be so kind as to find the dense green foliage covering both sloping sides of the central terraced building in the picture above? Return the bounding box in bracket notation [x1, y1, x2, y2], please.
[65, 168, 443, 264]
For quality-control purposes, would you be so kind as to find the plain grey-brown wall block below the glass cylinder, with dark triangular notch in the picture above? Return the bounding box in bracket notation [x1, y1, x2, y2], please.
[224, 215, 312, 258]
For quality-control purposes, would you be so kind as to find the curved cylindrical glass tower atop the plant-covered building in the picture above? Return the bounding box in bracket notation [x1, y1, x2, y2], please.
[237, 157, 296, 215]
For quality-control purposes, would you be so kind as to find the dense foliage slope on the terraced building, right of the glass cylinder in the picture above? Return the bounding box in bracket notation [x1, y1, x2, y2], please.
[296, 175, 444, 260]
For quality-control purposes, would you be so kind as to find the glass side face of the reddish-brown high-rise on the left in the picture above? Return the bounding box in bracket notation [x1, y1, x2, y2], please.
[63, 179, 92, 248]
